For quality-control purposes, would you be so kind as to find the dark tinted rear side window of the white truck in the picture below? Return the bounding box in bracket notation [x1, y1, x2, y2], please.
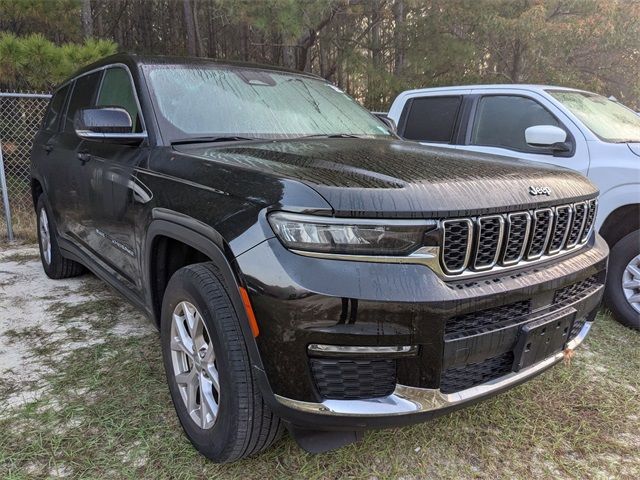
[402, 97, 462, 143]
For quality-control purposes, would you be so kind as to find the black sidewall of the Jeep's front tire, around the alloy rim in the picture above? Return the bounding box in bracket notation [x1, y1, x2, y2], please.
[161, 267, 250, 462]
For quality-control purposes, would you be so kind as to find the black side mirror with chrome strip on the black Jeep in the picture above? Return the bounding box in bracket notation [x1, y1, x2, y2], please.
[73, 107, 147, 144]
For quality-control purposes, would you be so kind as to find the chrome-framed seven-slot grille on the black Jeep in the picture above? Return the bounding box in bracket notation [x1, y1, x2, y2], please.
[440, 199, 597, 274]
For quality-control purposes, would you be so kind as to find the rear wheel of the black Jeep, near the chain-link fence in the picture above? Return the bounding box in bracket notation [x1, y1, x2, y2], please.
[36, 193, 84, 280]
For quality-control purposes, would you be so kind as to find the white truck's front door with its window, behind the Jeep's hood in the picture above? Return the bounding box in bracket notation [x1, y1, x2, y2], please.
[459, 89, 589, 175]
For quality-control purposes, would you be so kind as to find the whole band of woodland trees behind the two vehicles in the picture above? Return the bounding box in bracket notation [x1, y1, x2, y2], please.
[0, 0, 640, 110]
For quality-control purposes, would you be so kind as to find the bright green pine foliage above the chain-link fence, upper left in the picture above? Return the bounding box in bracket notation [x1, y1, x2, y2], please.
[0, 32, 117, 90]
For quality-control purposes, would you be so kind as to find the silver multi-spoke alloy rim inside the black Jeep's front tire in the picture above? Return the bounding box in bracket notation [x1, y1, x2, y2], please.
[171, 301, 220, 430]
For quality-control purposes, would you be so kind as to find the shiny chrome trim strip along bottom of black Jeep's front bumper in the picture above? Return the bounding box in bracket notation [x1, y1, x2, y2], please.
[275, 322, 592, 418]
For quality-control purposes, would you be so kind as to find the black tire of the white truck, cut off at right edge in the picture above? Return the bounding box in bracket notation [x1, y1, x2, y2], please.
[605, 230, 640, 329]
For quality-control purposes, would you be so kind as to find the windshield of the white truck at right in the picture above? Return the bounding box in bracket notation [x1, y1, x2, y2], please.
[548, 90, 640, 143]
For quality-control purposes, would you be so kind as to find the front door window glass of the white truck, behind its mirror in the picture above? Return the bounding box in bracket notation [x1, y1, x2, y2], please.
[471, 95, 564, 153]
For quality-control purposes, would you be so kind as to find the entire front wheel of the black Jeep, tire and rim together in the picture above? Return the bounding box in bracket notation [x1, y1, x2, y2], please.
[160, 263, 283, 463]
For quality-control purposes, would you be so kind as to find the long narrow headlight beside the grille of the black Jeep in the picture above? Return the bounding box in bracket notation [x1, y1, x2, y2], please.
[268, 212, 435, 255]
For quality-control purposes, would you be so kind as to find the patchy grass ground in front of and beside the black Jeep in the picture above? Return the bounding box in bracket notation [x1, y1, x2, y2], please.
[0, 286, 640, 479]
